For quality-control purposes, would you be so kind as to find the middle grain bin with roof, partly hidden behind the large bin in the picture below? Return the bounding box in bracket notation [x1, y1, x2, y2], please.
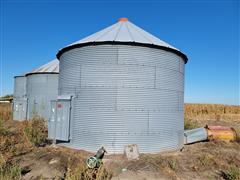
[26, 59, 59, 120]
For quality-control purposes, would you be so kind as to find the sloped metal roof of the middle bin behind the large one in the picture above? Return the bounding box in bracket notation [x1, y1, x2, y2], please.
[26, 59, 59, 76]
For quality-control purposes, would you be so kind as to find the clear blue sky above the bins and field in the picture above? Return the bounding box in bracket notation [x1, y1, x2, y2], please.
[0, 0, 240, 105]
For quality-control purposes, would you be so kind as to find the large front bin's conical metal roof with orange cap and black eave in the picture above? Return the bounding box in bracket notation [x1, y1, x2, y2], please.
[57, 18, 187, 62]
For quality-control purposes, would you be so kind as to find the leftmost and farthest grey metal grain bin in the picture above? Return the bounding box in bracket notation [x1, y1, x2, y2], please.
[13, 76, 27, 121]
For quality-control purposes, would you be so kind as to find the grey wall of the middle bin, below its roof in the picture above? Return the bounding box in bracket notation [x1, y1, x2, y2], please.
[27, 74, 58, 120]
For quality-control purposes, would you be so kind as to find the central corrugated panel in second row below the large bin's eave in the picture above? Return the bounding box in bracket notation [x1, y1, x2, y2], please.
[81, 64, 155, 88]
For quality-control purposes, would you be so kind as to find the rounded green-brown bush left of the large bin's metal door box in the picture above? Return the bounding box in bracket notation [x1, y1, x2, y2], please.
[24, 118, 47, 146]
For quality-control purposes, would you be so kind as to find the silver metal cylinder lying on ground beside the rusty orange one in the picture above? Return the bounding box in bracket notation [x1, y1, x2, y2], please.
[184, 128, 208, 144]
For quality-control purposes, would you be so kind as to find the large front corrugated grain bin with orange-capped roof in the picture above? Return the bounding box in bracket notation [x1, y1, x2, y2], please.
[52, 18, 187, 153]
